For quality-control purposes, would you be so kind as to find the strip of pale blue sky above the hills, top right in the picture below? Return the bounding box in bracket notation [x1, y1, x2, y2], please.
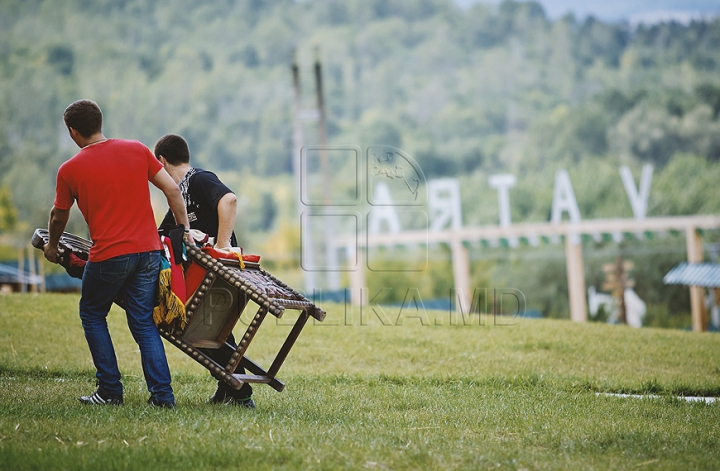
[456, 0, 720, 24]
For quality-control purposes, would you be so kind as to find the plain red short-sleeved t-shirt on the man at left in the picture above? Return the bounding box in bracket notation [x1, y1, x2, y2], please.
[54, 139, 163, 262]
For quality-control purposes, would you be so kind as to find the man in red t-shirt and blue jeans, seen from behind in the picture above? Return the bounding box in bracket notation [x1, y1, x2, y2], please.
[45, 100, 190, 408]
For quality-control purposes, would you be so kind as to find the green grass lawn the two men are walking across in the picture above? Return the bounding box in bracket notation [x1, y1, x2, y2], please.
[0, 295, 720, 470]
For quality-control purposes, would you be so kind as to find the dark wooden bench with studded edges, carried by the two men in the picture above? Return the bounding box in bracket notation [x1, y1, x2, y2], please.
[32, 229, 325, 391]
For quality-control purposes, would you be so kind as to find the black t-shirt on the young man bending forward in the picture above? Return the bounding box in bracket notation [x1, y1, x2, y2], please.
[159, 168, 237, 247]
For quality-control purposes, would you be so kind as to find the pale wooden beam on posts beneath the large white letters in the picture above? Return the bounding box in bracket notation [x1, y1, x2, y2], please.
[343, 215, 720, 332]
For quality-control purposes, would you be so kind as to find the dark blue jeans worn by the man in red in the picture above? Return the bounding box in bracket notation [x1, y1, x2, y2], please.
[80, 251, 175, 402]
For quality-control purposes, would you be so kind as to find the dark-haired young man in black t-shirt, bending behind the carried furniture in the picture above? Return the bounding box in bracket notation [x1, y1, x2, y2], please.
[155, 134, 255, 408]
